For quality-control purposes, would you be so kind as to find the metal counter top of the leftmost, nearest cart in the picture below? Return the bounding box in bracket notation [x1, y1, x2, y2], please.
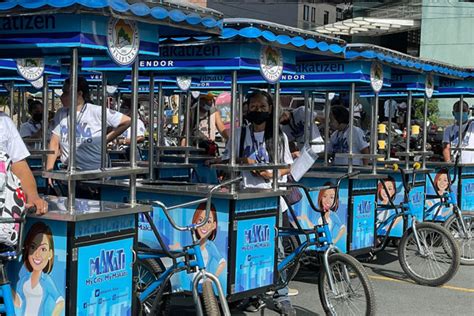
[29, 196, 151, 222]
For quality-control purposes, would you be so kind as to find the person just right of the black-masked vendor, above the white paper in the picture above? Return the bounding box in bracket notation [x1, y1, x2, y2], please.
[280, 106, 324, 159]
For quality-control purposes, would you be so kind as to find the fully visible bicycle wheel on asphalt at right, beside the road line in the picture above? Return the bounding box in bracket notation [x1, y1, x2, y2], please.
[398, 223, 460, 286]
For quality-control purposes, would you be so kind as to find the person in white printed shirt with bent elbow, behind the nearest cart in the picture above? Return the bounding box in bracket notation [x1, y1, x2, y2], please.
[46, 77, 130, 175]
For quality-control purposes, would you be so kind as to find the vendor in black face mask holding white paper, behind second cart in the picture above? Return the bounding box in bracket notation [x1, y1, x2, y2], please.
[222, 91, 295, 315]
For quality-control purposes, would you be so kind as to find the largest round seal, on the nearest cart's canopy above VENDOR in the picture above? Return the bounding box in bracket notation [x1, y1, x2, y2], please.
[107, 18, 140, 66]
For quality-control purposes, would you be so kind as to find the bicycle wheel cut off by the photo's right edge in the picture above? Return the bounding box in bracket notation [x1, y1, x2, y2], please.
[443, 212, 474, 265]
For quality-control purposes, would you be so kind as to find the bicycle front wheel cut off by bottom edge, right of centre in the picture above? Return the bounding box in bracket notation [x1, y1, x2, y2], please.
[318, 253, 375, 316]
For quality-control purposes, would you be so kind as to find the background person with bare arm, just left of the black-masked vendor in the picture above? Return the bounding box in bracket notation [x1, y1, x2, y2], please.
[181, 93, 229, 146]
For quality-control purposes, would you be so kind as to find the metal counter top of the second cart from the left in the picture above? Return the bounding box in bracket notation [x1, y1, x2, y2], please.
[87, 179, 287, 200]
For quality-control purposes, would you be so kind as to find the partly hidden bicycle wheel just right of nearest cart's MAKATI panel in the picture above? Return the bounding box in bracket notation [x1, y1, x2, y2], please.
[136, 259, 171, 316]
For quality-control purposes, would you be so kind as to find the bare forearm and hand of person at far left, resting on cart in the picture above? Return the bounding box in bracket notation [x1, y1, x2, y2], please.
[12, 159, 48, 214]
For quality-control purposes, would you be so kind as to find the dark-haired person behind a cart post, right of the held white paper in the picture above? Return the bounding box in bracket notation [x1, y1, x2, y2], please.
[327, 105, 369, 166]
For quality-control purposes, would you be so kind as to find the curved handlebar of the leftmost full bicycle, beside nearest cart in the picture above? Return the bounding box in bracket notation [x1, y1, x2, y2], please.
[152, 177, 242, 231]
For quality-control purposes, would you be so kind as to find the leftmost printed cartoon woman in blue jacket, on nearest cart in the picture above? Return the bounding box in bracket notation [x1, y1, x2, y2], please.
[15, 222, 64, 316]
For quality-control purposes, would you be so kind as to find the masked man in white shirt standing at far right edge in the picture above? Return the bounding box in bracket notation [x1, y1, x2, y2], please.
[443, 101, 474, 163]
